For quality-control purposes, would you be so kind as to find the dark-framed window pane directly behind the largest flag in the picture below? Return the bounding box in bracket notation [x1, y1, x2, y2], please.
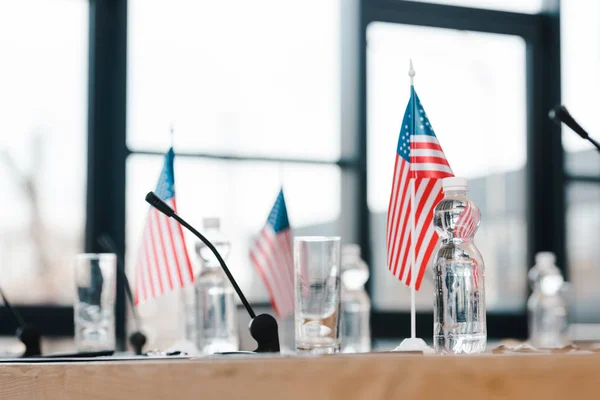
[367, 23, 528, 310]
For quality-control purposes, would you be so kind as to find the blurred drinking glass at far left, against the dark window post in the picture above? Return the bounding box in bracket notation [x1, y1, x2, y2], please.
[74, 254, 117, 351]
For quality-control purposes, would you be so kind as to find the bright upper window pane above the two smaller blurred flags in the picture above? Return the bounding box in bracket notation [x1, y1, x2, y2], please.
[127, 0, 340, 160]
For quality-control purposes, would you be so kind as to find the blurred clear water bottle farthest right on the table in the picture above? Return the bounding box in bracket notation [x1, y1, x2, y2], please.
[527, 252, 569, 348]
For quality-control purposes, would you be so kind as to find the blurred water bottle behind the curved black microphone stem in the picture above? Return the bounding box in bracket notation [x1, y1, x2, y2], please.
[195, 218, 239, 354]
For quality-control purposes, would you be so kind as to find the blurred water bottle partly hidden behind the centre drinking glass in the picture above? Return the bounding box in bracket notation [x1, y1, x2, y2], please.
[341, 244, 371, 353]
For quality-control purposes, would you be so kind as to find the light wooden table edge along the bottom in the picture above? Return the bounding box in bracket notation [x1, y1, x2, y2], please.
[0, 353, 600, 400]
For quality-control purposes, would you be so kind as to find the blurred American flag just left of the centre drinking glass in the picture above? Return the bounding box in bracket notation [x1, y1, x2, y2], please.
[250, 189, 294, 317]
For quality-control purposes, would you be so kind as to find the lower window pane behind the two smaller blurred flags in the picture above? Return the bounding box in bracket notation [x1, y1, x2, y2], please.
[127, 155, 341, 303]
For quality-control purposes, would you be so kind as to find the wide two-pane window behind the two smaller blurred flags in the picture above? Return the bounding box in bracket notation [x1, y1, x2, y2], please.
[126, 0, 351, 339]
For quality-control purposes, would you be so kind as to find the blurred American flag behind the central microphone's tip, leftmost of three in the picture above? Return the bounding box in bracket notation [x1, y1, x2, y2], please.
[135, 148, 194, 304]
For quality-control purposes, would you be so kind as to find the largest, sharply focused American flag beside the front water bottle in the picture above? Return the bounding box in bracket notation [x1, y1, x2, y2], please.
[386, 86, 454, 290]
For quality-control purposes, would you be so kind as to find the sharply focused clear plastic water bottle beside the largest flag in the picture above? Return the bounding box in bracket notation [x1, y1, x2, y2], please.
[433, 178, 487, 354]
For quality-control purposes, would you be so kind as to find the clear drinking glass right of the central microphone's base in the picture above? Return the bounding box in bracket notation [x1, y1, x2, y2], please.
[294, 236, 341, 354]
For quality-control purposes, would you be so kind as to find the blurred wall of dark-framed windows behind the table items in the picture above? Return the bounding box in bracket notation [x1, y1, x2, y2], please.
[0, 0, 600, 345]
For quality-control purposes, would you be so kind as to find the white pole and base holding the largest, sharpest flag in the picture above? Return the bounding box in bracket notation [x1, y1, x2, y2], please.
[394, 60, 433, 353]
